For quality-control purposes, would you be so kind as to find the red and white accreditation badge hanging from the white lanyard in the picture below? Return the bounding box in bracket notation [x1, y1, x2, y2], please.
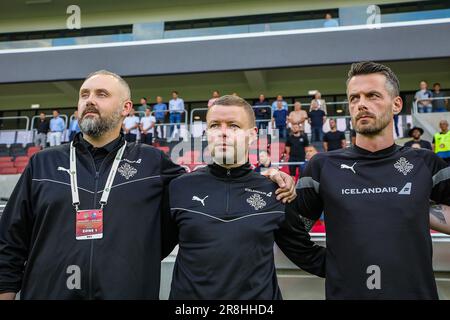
[75, 209, 103, 240]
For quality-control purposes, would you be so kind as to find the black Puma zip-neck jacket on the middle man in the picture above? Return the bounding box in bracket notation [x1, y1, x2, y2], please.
[169, 164, 325, 300]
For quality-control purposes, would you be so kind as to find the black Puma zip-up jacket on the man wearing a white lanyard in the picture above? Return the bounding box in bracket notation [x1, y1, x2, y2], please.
[0, 134, 184, 299]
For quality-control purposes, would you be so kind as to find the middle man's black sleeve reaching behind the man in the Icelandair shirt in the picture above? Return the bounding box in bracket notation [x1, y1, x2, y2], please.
[275, 202, 326, 278]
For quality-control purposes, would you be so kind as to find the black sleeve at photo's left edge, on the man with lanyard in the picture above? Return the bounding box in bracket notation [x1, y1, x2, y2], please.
[0, 160, 33, 293]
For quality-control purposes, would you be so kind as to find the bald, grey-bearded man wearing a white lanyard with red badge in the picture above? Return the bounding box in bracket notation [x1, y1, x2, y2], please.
[0, 70, 296, 299]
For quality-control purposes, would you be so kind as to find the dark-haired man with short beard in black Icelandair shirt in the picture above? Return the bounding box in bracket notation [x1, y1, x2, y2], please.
[297, 62, 450, 299]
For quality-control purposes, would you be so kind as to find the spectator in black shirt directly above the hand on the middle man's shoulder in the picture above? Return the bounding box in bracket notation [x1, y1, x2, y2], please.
[286, 123, 309, 177]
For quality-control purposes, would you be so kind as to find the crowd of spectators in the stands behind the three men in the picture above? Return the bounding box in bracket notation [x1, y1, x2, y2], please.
[0, 81, 450, 177]
